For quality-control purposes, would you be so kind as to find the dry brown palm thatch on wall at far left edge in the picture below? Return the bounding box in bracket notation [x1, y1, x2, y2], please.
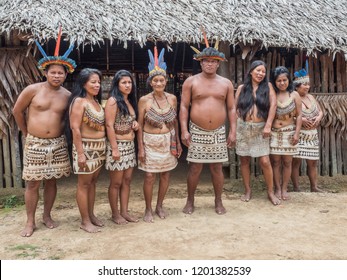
[0, 48, 41, 139]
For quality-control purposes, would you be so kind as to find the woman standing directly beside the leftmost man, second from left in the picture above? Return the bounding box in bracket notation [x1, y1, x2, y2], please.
[69, 68, 106, 233]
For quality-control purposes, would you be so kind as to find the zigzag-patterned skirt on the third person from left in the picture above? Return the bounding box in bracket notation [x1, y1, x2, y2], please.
[105, 140, 136, 171]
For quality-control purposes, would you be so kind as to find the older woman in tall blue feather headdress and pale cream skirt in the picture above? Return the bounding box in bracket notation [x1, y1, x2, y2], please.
[138, 47, 182, 223]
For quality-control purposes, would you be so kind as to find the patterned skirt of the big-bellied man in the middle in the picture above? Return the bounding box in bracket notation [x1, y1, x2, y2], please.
[187, 121, 228, 163]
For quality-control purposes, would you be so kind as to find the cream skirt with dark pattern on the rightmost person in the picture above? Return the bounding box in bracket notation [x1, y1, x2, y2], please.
[294, 129, 319, 160]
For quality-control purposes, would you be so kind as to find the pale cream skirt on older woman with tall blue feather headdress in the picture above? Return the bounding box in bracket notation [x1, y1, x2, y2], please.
[138, 132, 177, 173]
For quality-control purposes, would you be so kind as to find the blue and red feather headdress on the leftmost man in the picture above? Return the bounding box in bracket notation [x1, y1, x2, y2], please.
[35, 26, 76, 73]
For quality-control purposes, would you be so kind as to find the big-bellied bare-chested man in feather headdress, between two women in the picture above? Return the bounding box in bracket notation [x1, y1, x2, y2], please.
[179, 40, 236, 214]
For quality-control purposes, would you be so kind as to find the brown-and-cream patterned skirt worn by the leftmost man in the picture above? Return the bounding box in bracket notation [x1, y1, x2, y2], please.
[22, 134, 71, 181]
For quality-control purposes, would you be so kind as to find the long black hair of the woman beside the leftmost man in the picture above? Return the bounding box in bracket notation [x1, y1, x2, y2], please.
[65, 68, 102, 154]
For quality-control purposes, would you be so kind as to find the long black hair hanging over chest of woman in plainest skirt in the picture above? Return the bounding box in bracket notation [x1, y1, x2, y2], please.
[236, 60, 270, 121]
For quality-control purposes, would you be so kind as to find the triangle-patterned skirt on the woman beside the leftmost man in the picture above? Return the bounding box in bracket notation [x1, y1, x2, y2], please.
[72, 137, 106, 174]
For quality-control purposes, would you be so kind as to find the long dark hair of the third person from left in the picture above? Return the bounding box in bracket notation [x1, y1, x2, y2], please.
[110, 70, 137, 116]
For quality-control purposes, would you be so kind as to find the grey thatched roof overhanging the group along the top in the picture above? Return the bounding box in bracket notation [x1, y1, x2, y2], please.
[0, 0, 347, 58]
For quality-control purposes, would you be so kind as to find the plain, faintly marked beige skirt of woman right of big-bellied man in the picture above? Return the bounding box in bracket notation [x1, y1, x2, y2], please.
[236, 119, 270, 157]
